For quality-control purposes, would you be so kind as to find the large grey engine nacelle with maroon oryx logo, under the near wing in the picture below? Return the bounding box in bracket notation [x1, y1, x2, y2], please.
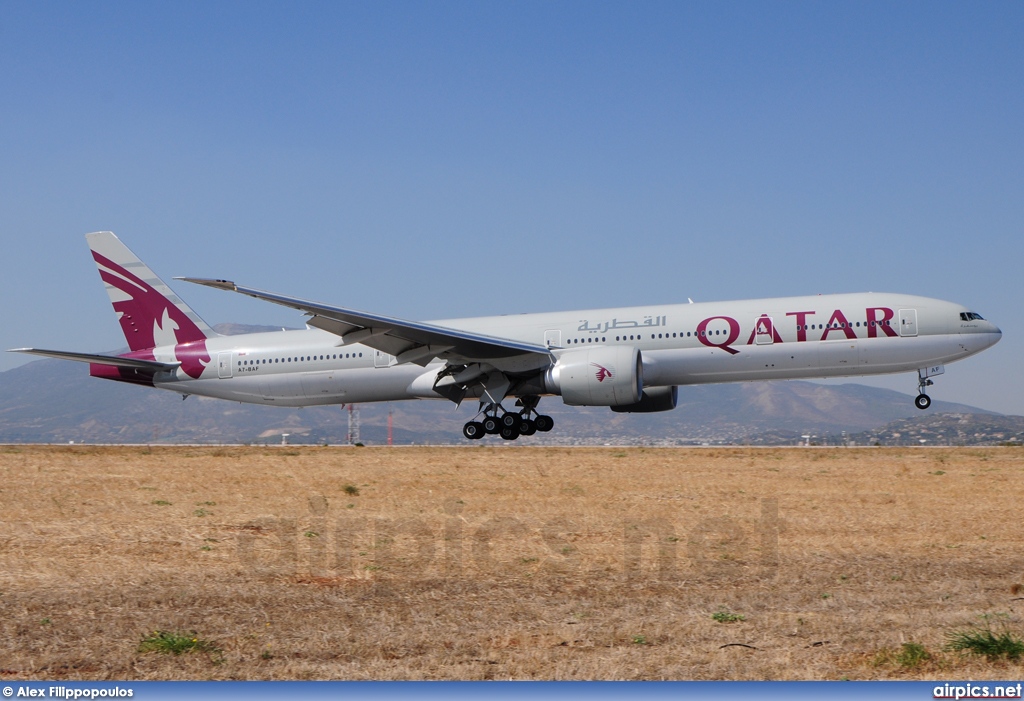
[544, 346, 643, 406]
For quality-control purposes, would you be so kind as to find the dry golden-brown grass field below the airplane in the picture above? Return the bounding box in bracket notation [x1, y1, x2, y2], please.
[0, 446, 1024, 680]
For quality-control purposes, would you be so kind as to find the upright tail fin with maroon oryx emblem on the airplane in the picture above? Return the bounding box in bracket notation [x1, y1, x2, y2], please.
[85, 231, 217, 351]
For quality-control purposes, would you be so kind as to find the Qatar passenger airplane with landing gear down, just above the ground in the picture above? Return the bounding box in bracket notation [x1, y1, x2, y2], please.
[12, 231, 1001, 440]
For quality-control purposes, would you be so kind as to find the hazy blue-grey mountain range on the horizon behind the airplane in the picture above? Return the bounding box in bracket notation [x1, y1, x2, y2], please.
[0, 324, 991, 444]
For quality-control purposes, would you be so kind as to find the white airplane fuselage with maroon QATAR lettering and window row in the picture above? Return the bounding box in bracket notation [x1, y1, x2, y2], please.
[154, 293, 1000, 406]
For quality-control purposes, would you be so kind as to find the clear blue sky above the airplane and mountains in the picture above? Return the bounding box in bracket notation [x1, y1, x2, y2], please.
[0, 2, 1024, 413]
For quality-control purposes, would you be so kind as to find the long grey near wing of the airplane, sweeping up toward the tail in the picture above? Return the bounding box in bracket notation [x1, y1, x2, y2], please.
[175, 277, 550, 366]
